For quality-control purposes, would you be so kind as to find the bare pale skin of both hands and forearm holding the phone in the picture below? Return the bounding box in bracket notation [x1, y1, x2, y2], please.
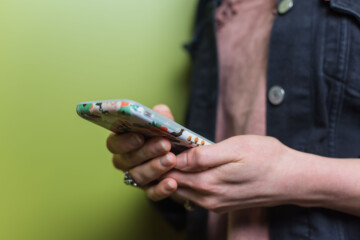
[107, 105, 360, 216]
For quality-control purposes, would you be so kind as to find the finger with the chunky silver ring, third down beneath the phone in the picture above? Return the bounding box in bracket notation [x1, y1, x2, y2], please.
[130, 152, 176, 186]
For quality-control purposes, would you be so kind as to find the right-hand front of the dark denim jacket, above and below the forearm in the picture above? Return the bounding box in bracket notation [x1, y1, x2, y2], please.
[267, 0, 360, 239]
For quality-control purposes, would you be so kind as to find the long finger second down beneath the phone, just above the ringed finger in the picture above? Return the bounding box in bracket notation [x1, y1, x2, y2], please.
[113, 137, 171, 170]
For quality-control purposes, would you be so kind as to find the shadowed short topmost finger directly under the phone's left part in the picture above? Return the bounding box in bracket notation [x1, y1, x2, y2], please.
[106, 133, 144, 154]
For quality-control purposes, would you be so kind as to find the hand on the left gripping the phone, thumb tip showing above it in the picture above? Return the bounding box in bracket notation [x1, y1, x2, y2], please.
[107, 105, 177, 201]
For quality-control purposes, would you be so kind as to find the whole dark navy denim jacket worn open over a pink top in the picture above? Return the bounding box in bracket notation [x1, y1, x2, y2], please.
[157, 0, 360, 240]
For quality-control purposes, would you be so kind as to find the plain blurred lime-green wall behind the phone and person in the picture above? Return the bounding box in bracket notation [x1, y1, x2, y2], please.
[0, 0, 196, 240]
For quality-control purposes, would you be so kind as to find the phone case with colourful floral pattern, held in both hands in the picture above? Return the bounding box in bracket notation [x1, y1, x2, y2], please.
[76, 99, 213, 153]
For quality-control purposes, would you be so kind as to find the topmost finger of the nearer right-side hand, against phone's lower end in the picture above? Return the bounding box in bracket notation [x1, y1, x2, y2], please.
[175, 138, 240, 172]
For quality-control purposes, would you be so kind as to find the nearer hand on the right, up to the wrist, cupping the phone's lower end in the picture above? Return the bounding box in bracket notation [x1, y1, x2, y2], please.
[165, 135, 299, 213]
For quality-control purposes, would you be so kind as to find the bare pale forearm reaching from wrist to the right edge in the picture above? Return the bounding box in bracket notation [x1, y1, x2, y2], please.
[289, 150, 360, 216]
